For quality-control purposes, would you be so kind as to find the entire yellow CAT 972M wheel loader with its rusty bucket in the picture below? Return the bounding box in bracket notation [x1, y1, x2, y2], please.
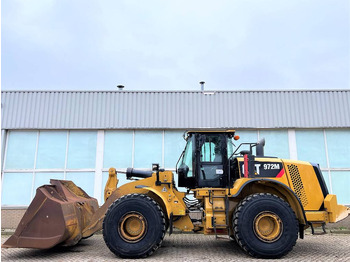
[2, 130, 350, 258]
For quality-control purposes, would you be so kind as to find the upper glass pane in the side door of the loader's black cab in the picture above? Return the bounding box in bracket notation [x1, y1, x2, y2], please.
[200, 136, 222, 162]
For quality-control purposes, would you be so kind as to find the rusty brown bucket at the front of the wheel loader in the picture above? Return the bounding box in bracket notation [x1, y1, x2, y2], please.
[2, 179, 98, 249]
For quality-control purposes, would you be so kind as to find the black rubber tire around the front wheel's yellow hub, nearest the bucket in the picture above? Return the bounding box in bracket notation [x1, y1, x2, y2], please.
[103, 196, 164, 258]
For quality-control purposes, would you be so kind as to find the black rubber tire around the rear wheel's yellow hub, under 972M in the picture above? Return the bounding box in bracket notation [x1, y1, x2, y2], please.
[238, 195, 298, 258]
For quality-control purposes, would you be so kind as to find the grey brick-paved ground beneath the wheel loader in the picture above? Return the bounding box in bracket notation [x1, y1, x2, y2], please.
[1, 234, 350, 262]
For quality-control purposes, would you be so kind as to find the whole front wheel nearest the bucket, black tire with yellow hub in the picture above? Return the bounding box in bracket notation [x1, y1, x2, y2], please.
[103, 194, 165, 258]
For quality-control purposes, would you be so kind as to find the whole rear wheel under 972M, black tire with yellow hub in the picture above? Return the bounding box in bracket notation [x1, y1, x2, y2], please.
[232, 193, 299, 258]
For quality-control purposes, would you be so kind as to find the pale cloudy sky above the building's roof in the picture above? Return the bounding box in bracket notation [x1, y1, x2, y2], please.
[1, 0, 350, 90]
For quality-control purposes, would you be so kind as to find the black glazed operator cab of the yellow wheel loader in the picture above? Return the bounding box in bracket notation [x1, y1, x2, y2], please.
[177, 130, 239, 188]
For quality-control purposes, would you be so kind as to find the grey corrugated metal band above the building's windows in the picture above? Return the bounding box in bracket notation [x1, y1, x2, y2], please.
[1, 90, 350, 129]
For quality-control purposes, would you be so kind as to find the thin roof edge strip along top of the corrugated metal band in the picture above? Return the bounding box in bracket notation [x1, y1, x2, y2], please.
[1, 89, 350, 94]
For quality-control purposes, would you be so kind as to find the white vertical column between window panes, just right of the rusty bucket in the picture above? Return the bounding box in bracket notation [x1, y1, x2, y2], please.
[94, 130, 105, 205]
